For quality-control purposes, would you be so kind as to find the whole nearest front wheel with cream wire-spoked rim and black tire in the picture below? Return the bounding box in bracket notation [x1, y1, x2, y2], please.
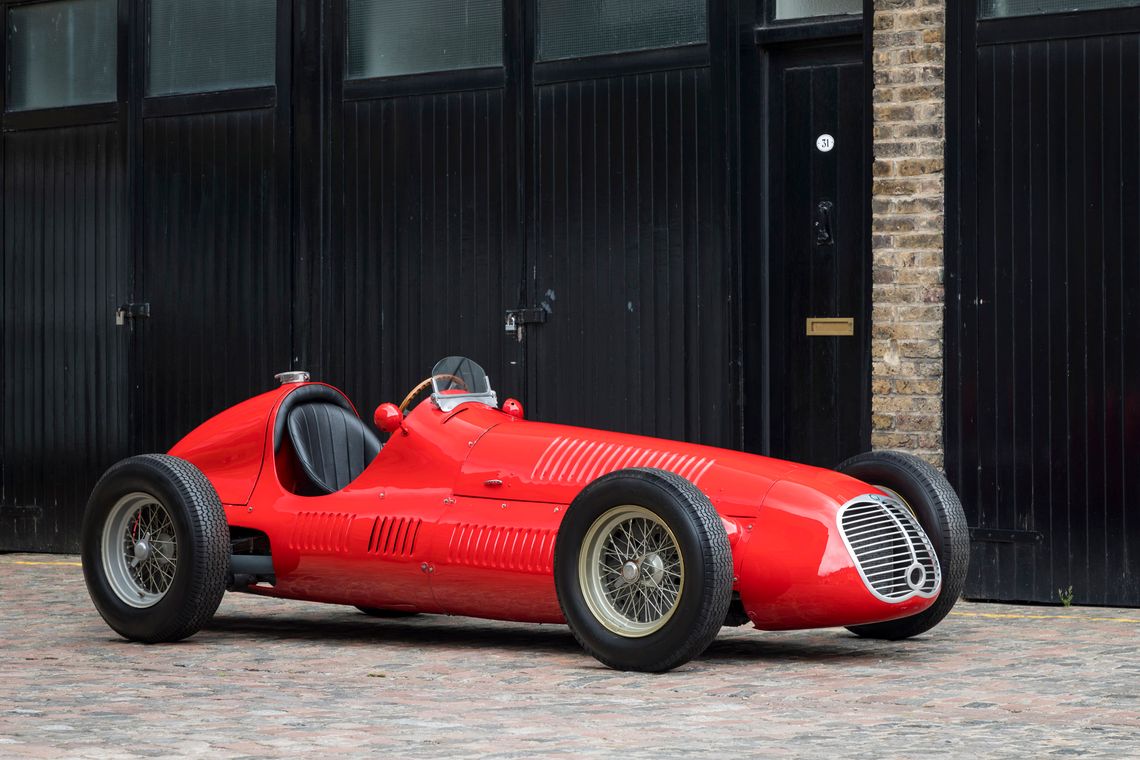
[554, 468, 732, 672]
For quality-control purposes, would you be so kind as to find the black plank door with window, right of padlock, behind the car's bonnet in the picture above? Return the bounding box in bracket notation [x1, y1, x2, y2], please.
[524, 0, 740, 446]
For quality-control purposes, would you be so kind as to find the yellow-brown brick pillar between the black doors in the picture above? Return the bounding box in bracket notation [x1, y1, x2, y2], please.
[871, 0, 946, 467]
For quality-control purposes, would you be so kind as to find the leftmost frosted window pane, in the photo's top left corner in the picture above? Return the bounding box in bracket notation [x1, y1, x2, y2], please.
[8, 0, 119, 111]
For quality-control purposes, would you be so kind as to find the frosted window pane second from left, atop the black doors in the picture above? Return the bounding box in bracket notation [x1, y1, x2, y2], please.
[147, 0, 277, 95]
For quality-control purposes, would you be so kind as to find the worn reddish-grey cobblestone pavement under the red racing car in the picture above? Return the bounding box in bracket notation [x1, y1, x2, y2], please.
[0, 555, 1140, 758]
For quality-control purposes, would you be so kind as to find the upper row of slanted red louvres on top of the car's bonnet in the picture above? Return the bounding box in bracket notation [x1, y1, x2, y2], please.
[530, 436, 716, 484]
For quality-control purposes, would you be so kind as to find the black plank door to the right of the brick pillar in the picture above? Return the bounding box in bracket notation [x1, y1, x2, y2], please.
[946, 2, 1140, 605]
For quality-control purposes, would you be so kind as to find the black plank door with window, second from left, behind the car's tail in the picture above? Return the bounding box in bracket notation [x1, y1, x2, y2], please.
[131, 0, 293, 451]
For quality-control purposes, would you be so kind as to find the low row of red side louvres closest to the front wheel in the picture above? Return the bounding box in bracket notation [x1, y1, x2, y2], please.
[448, 523, 554, 573]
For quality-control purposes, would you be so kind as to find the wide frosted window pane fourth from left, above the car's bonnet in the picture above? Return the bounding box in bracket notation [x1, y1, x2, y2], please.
[538, 0, 708, 60]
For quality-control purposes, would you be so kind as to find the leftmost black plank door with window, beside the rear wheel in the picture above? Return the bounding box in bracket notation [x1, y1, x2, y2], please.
[0, 0, 130, 550]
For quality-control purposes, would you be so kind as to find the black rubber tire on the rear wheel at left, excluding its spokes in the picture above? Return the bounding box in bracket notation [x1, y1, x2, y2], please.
[82, 453, 230, 644]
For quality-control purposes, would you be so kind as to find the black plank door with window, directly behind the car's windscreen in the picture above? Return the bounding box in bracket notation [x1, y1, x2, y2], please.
[323, 0, 524, 415]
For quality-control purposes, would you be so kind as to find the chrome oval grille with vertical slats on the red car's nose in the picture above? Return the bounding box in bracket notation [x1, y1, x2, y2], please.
[837, 493, 942, 602]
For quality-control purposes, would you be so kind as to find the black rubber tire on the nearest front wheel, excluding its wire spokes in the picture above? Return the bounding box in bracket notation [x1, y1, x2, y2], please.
[554, 468, 732, 672]
